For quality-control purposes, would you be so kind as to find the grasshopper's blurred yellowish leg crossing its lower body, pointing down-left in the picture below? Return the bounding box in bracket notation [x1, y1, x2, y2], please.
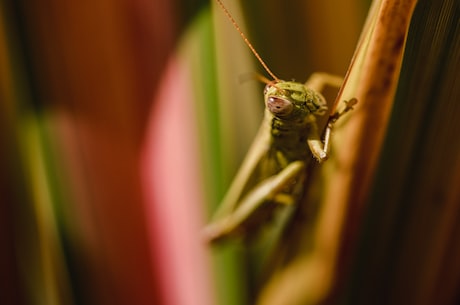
[204, 161, 305, 242]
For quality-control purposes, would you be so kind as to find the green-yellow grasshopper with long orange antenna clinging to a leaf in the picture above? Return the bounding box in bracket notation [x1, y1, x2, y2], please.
[205, 0, 357, 242]
